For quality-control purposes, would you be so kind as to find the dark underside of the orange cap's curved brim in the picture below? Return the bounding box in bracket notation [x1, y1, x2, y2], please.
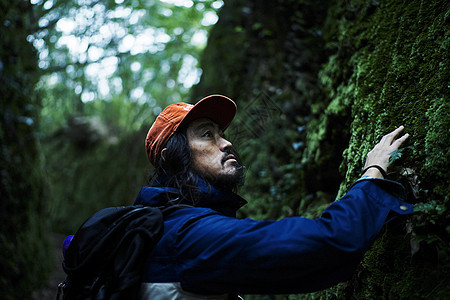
[177, 95, 237, 130]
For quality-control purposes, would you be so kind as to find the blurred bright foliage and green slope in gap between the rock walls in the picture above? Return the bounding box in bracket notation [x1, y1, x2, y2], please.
[28, 0, 222, 232]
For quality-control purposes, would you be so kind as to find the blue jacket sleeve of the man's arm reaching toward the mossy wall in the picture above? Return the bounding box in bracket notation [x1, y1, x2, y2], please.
[176, 179, 413, 294]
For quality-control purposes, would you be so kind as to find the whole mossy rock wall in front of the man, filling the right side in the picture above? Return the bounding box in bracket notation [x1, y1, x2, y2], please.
[193, 0, 450, 299]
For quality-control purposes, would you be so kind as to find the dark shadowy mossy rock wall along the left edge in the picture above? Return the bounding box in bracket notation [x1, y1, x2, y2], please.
[0, 0, 53, 299]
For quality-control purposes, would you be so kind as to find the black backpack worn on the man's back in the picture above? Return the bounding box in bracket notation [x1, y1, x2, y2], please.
[57, 205, 164, 300]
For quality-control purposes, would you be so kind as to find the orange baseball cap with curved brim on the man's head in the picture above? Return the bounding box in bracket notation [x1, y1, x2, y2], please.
[145, 95, 237, 165]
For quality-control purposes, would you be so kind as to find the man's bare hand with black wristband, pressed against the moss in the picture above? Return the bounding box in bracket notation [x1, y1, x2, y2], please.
[362, 126, 409, 178]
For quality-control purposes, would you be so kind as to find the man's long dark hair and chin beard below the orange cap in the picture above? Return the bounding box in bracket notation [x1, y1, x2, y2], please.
[148, 129, 244, 205]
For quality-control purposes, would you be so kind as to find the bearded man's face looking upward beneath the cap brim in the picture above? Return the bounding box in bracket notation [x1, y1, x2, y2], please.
[186, 118, 243, 187]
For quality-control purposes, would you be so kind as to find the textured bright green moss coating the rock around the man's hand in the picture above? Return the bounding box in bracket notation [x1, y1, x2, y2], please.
[318, 1, 449, 299]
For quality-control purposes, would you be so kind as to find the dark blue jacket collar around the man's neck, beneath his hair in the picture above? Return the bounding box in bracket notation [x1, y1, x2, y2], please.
[134, 177, 247, 217]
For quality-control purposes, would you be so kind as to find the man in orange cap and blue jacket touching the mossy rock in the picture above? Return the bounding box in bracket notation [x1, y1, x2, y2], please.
[136, 95, 413, 299]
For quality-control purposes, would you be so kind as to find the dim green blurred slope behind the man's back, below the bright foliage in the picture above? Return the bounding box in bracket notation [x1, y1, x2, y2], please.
[45, 123, 149, 233]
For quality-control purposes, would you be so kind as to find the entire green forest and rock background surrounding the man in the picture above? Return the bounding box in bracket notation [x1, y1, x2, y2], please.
[0, 0, 450, 299]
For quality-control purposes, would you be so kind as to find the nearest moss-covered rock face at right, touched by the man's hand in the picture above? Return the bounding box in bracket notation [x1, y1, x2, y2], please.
[319, 1, 450, 299]
